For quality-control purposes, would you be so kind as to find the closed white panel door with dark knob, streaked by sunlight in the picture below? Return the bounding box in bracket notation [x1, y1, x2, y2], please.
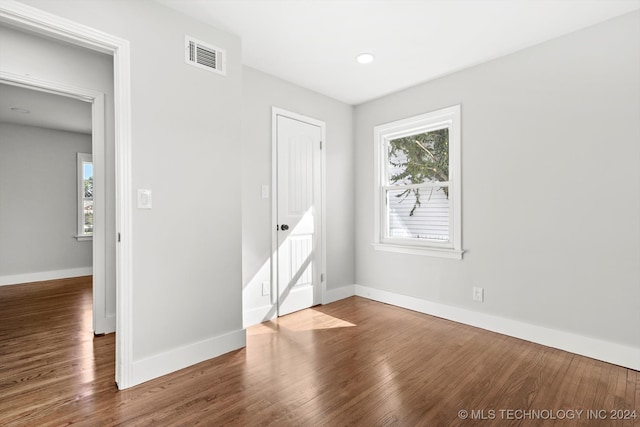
[276, 115, 322, 316]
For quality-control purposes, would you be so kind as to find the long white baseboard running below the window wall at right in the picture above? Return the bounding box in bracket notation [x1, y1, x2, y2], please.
[355, 285, 640, 370]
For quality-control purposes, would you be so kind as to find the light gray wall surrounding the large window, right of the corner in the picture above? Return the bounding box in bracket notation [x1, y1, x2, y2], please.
[355, 13, 640, 347]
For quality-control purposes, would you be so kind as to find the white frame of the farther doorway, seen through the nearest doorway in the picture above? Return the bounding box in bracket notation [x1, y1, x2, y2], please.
[0, 70, 110, 334]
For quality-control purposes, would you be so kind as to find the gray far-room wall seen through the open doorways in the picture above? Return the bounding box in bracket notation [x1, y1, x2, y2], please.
[0, 123, 92, 279]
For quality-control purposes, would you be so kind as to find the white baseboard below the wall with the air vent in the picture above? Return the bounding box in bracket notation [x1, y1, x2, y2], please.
[128, 329, 247, 387]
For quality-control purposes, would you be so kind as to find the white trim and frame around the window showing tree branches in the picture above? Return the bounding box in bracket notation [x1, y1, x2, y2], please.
[373, 105, 464, 259]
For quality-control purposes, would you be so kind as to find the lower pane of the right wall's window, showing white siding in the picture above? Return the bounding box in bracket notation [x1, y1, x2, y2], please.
[387, 187, 449, 242]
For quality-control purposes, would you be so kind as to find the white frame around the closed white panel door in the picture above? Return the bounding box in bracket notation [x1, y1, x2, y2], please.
[269, 107, 327, 316]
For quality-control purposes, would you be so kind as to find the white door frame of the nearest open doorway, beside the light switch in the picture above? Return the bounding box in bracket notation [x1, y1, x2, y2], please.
[0, 0, 133, 389]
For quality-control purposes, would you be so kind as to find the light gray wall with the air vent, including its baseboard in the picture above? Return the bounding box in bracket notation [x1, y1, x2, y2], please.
[15, 0, 244, 382]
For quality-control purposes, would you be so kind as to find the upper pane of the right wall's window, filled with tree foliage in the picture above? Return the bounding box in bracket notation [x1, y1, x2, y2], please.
[388, 128, 449, 185]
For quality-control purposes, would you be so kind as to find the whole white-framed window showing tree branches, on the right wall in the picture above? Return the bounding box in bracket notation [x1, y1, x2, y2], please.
[374, 105, 462, 259]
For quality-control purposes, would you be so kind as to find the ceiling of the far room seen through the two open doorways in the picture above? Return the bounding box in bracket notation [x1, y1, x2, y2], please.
[0, 84, 91, 134]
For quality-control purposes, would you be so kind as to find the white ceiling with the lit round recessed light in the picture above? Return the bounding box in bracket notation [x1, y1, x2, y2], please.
[157, 0, 640, 104]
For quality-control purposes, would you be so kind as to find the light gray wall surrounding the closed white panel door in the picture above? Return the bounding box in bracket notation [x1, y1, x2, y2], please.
[242, 67, 355, 325]
